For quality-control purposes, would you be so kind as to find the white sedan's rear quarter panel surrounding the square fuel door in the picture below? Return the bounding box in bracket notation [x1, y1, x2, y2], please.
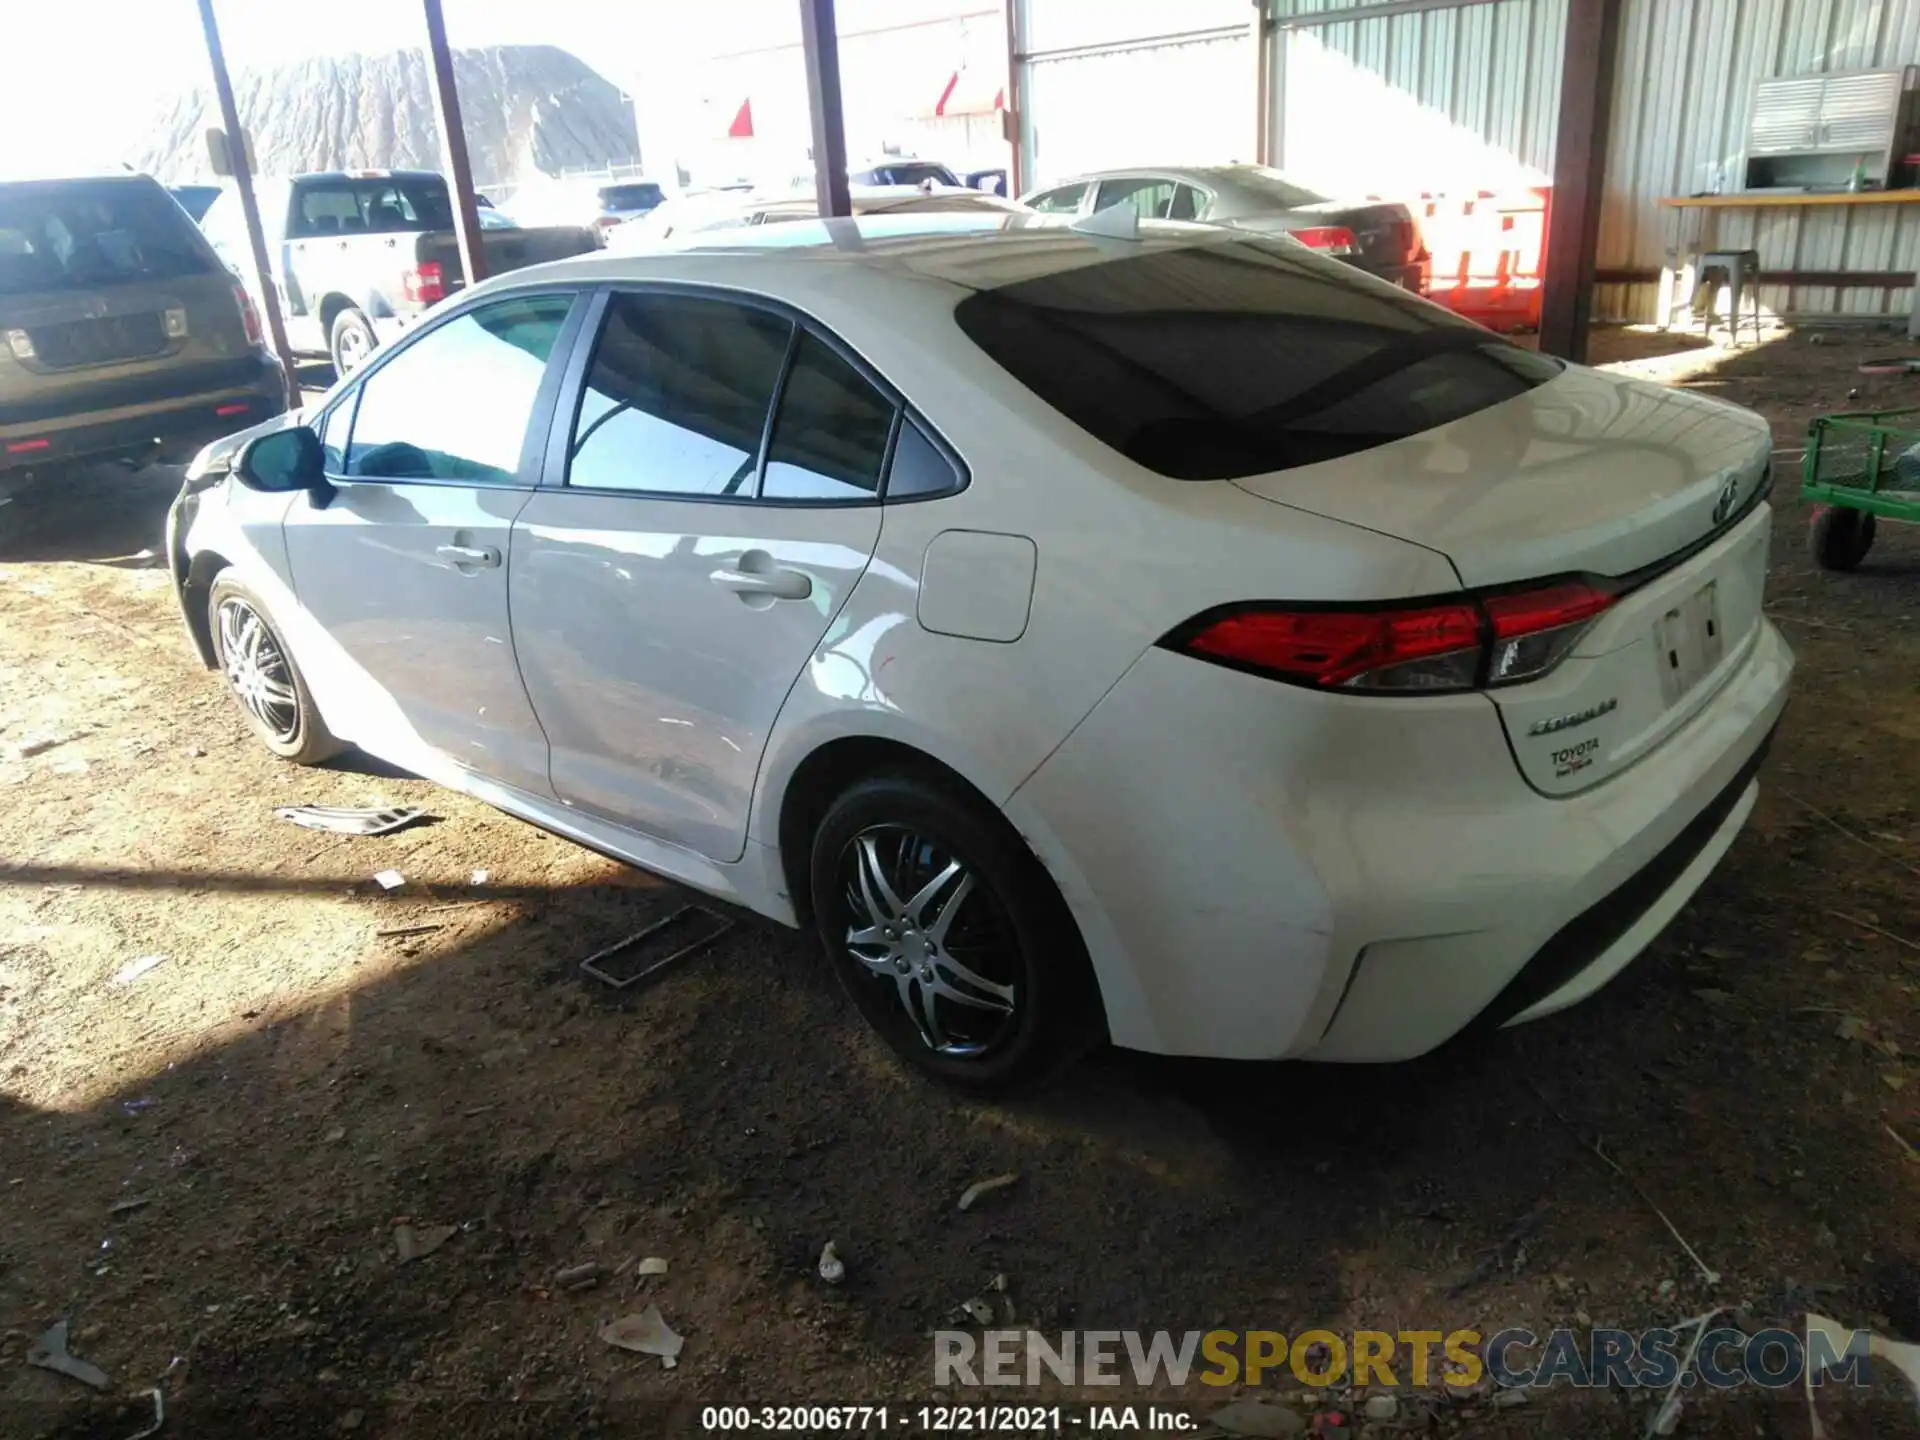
[749, 278, 1459, 1016]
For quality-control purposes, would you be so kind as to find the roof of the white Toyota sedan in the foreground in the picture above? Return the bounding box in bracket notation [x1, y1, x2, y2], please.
[499, 211, 1244, 298]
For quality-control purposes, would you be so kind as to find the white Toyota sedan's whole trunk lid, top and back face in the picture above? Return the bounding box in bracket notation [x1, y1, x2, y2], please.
[1235, 367, 1770, 795]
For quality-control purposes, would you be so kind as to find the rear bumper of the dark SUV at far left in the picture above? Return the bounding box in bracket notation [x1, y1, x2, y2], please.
[0, 355, 286, 472]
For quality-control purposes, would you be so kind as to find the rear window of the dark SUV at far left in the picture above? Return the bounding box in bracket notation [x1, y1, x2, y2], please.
[0, 180, 213, 296]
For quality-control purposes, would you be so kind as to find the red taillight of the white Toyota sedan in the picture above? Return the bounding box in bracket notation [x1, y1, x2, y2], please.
[1167, 580, 1613, 693]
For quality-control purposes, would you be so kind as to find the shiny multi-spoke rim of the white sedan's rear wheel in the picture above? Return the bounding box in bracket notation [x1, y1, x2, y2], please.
[839, 826, 1021, 1060]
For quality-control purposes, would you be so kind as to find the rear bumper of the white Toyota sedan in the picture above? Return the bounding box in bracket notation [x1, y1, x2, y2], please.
[1010, 620, 1793, 1060]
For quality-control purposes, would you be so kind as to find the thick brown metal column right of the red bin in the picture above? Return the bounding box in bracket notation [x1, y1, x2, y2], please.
[1540, 0, 1622, 361]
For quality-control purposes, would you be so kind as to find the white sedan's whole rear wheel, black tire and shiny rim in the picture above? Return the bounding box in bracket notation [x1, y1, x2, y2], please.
[810, 774, 1102, 1092]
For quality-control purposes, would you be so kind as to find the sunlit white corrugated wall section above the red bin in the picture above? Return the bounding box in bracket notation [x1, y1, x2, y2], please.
[1275, 0, 1567, 194]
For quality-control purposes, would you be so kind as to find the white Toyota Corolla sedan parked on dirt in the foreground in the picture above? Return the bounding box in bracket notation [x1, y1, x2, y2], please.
[169, 217, 1793, 1089]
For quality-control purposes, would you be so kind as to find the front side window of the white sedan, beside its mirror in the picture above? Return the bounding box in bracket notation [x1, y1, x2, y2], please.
[347, 296, 572, 486]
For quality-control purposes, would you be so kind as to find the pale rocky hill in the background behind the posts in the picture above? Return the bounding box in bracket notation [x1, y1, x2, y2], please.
[134, 44, 639, 184]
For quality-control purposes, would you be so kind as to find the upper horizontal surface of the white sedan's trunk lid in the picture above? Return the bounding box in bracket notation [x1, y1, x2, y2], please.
[1233, 365, 1772, 586]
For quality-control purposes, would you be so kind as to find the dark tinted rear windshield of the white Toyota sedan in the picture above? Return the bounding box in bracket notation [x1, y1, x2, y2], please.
[954, 240, 1559, 480]
